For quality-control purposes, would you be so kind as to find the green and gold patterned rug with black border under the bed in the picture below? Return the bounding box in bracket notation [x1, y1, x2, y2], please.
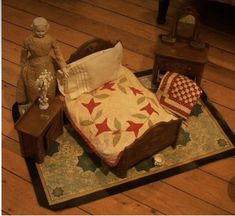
[28, 76, 235, 209]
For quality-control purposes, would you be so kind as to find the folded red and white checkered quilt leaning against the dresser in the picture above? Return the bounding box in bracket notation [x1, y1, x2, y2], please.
[157, 72, 202, 119]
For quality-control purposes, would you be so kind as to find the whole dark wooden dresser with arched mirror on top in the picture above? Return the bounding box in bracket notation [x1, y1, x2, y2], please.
[152, 7, 209, 90]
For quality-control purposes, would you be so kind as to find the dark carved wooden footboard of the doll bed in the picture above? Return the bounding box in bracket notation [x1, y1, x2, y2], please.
[114, 119, 182, 178]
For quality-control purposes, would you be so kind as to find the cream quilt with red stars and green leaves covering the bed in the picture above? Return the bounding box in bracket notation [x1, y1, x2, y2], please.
[65, 67, 176, 166]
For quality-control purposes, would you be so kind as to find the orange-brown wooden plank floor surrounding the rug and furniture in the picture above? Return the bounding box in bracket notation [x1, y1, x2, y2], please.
[2, 0, 235, 215]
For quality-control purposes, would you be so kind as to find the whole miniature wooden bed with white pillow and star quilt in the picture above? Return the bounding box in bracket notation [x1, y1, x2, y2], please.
[59, 39, 181, 178]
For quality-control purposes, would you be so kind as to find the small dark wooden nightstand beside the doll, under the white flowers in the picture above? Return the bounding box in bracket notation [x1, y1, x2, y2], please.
[15, 98, 63, 163]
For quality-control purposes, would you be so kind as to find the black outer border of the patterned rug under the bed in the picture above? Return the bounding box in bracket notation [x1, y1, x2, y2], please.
[25, 70, 235, 210]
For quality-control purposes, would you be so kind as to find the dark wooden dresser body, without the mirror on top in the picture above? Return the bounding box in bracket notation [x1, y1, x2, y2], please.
[151, 38, 208, 90]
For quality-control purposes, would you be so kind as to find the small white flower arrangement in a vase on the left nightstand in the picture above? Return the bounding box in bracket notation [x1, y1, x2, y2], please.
[36, 69, 53, 110]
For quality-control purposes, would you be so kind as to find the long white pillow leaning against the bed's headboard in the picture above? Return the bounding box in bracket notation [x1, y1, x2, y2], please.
[58, 42, 123, 99]
